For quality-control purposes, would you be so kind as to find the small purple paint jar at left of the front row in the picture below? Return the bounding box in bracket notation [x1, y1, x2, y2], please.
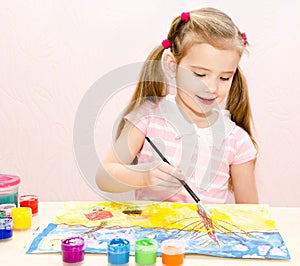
[61, 236, 84, 265]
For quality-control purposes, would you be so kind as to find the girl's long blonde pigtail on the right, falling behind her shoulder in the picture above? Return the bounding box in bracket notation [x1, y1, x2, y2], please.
[226, 67, 257, 148]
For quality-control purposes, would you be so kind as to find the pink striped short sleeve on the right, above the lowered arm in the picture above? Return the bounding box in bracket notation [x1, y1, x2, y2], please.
[232, 127, 257, 164]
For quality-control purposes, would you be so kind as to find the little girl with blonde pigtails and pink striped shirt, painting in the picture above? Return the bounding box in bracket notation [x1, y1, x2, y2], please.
[96, 8, 258, 203]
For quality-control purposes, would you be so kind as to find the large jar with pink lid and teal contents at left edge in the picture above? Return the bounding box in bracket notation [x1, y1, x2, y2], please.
[0, 174, 21, 206]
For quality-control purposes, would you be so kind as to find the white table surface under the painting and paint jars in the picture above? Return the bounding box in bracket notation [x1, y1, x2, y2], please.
[0, 202, 300, 266]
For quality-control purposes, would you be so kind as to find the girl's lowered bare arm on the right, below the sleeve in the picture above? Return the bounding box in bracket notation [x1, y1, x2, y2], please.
[230, 160, 258, 204]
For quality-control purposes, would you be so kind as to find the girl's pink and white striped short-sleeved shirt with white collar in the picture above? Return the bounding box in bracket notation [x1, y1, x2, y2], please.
[125, 95, 257, 203]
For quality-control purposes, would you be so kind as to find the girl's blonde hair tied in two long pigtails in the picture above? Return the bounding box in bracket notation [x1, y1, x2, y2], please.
[117, 8, 256, 148]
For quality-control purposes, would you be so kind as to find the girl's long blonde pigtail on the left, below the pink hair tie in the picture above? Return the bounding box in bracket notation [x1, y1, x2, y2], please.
[116, 46, 167, 139]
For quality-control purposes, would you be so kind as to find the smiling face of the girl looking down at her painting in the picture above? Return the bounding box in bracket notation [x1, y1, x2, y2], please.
[176, 43, 240, 116]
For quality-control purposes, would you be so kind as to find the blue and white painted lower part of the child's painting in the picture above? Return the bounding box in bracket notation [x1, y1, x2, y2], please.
[27, 224, 290, 260]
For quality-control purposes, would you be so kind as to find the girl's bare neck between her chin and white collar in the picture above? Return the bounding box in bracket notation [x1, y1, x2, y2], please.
[175, 95, 219, 128]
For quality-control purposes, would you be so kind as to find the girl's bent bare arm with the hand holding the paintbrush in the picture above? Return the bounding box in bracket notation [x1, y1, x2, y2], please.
[96, 122, 177, 192]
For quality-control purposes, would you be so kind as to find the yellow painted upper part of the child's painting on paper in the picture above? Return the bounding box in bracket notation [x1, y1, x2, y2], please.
[54, 201, 276, 232]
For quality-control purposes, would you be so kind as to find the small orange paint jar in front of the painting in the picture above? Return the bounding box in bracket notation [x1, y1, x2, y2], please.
[161, 239, 185, 266]
